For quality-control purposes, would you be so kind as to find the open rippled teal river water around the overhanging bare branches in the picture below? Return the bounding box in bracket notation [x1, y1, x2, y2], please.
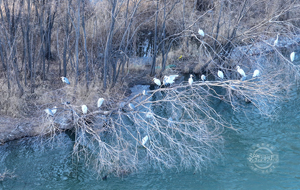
[0, 86, 300, 190]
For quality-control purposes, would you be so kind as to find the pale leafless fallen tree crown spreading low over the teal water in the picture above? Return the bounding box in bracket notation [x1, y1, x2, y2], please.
[65, 52, 288, 176]
